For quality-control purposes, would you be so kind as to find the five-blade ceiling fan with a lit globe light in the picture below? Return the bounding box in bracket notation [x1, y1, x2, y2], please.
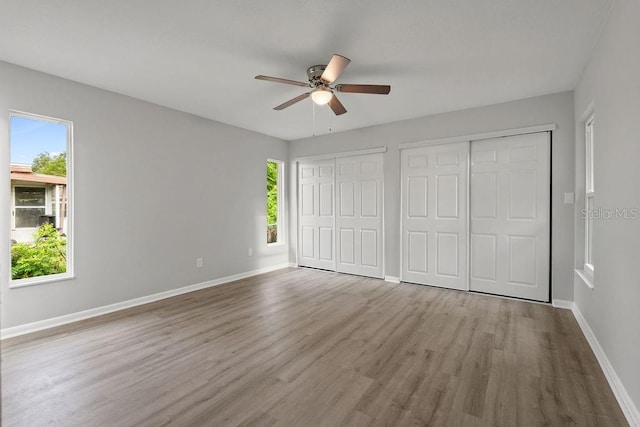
[256, 54, 391, 116]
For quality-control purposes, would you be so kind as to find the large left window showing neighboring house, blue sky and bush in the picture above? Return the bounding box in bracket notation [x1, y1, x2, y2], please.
[9, 112, 73, 287]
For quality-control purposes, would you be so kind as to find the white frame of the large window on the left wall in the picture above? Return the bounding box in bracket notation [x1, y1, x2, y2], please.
[7, 110, 75, 289]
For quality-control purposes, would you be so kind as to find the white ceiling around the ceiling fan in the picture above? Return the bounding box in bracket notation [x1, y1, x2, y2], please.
[0, 0, 612, 140]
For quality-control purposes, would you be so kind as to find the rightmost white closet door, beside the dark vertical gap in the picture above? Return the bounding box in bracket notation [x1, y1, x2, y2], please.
[470, 132, 550, 301]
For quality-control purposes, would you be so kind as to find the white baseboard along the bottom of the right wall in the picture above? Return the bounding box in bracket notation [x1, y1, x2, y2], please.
[571, 304, 640, 427]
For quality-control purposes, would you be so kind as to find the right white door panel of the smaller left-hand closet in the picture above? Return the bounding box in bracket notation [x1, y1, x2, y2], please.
[336, 154, 384, 278]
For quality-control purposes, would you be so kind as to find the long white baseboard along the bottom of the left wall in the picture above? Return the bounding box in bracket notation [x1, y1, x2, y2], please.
[0, 263, 290, 340]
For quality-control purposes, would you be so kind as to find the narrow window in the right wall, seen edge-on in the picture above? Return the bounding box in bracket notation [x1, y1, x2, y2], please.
[584, 115, 595, 281]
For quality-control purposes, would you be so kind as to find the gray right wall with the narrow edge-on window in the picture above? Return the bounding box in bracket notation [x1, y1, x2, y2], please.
[574, 0, 640, 414]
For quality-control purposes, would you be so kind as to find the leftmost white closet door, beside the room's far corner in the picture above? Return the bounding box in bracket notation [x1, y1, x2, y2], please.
[298, 159, 336, 270]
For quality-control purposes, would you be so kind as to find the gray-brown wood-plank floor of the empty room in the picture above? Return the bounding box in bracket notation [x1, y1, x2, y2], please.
[2, 269, 626, 427]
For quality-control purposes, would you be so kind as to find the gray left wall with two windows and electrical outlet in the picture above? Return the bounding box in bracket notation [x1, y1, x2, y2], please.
[0, 62, 288, 328]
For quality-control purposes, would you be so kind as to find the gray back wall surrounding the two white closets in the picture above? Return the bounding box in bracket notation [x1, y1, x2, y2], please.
[289, 92, 574, 301]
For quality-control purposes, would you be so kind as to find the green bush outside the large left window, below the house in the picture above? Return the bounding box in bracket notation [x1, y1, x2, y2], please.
[11, 224, 67, 280]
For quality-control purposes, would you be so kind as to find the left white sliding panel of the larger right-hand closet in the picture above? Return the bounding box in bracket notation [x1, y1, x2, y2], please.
[401, 142, 469, 290]
